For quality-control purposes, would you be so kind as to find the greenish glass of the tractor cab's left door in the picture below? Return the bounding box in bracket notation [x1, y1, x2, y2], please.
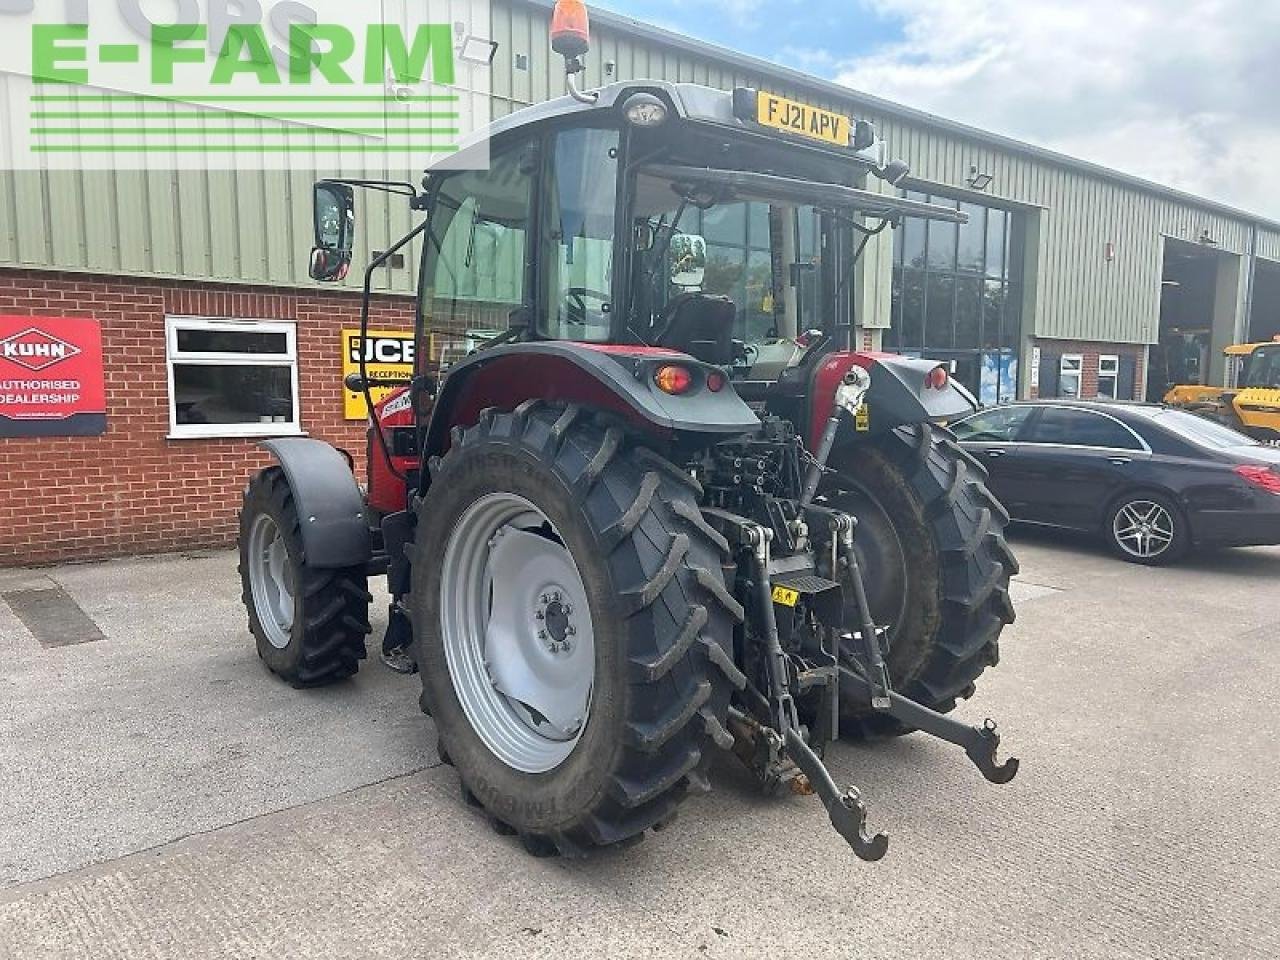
[421, 147, 536, 334]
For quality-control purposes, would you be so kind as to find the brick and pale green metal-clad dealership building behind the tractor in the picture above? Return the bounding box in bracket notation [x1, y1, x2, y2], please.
[0, 0, 1280, 564]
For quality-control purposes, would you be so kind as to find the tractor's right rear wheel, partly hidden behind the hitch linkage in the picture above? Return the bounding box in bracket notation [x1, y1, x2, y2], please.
[826, 424, 1018, 736]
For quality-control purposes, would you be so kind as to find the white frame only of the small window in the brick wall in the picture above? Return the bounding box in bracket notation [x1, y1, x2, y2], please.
[165, 316, 303, 440]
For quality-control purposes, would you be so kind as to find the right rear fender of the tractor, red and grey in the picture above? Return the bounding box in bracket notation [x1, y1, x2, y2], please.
[808, 353, 978, 449]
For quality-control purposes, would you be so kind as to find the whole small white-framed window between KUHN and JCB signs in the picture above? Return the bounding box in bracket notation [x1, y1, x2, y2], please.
[165, 316, 302, 438]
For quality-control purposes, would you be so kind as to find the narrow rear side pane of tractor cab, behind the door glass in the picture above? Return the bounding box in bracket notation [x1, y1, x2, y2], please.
[540, 129, 618, 342]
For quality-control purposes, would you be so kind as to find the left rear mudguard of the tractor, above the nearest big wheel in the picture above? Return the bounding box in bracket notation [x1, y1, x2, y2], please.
[426, 340, 760, 456]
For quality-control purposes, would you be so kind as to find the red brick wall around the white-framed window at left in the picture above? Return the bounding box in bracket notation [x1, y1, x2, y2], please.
[0, 270, 413, 566]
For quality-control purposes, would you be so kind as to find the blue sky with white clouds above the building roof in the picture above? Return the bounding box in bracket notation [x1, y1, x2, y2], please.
[595, 0, 1280, 220]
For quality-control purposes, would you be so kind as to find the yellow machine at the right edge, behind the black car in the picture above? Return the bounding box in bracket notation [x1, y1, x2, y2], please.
[1165, 337, 1280, 443]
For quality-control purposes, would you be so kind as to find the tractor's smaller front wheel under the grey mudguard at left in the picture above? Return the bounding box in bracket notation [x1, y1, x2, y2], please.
[239, 467, 372, 687]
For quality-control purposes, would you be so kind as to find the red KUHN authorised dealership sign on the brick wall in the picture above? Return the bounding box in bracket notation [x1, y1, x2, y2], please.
[0, 316, 106, 436]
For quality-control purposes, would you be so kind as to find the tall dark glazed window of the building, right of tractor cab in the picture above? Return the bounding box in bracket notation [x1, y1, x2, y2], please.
[884, 191, 1023, 404]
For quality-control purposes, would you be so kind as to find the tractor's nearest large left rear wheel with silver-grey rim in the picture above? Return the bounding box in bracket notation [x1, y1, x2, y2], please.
[411, 404, 742, 854]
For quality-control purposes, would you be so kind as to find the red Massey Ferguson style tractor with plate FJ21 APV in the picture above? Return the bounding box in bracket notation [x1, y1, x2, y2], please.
[241, 0, 1018, 860]
